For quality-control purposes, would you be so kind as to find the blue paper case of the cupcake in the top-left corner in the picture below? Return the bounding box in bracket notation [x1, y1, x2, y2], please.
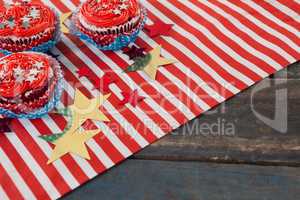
[0, 10, 61, 55]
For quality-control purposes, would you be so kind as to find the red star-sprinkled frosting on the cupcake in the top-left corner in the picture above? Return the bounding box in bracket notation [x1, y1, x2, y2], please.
[0, 1, 56, 37]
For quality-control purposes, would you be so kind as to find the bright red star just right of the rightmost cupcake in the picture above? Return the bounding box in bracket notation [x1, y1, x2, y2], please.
[145, 20, 174, 37]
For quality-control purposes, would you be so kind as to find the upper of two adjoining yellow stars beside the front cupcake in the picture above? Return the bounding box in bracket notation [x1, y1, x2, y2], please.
[69, 89, 110, 122]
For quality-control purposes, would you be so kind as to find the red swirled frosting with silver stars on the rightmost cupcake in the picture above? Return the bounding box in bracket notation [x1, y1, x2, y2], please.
[80, 0, 140, 28]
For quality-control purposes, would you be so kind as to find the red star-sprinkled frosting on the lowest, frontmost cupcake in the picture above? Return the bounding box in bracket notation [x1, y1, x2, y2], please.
[0, 53, 50, 98]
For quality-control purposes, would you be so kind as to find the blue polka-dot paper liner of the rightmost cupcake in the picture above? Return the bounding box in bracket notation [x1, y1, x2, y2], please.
[70, 8, 147, 51]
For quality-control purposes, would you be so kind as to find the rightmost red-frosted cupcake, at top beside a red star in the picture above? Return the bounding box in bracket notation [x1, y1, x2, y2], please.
[74, 0, 146, 50]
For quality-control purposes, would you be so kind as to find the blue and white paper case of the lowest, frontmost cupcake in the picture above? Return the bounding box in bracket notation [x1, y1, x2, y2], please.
[0, 53, 63, 119]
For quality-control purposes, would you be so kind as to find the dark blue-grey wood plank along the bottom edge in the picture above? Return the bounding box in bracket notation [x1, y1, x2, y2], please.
[63, 160, 300, 200]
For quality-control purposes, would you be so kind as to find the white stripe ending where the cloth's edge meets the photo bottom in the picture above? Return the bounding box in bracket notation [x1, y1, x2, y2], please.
[6, 134, 61, 199]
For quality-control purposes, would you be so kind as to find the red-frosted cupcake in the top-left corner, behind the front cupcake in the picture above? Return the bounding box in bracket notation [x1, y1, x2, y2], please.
[0, 1, 59, 53]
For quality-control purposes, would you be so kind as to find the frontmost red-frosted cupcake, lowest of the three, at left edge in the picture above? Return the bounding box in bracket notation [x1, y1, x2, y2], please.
[0, 52, 61, 117]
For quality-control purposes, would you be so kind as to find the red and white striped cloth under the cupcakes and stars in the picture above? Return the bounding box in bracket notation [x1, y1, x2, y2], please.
[0, 0, 300, 200]
